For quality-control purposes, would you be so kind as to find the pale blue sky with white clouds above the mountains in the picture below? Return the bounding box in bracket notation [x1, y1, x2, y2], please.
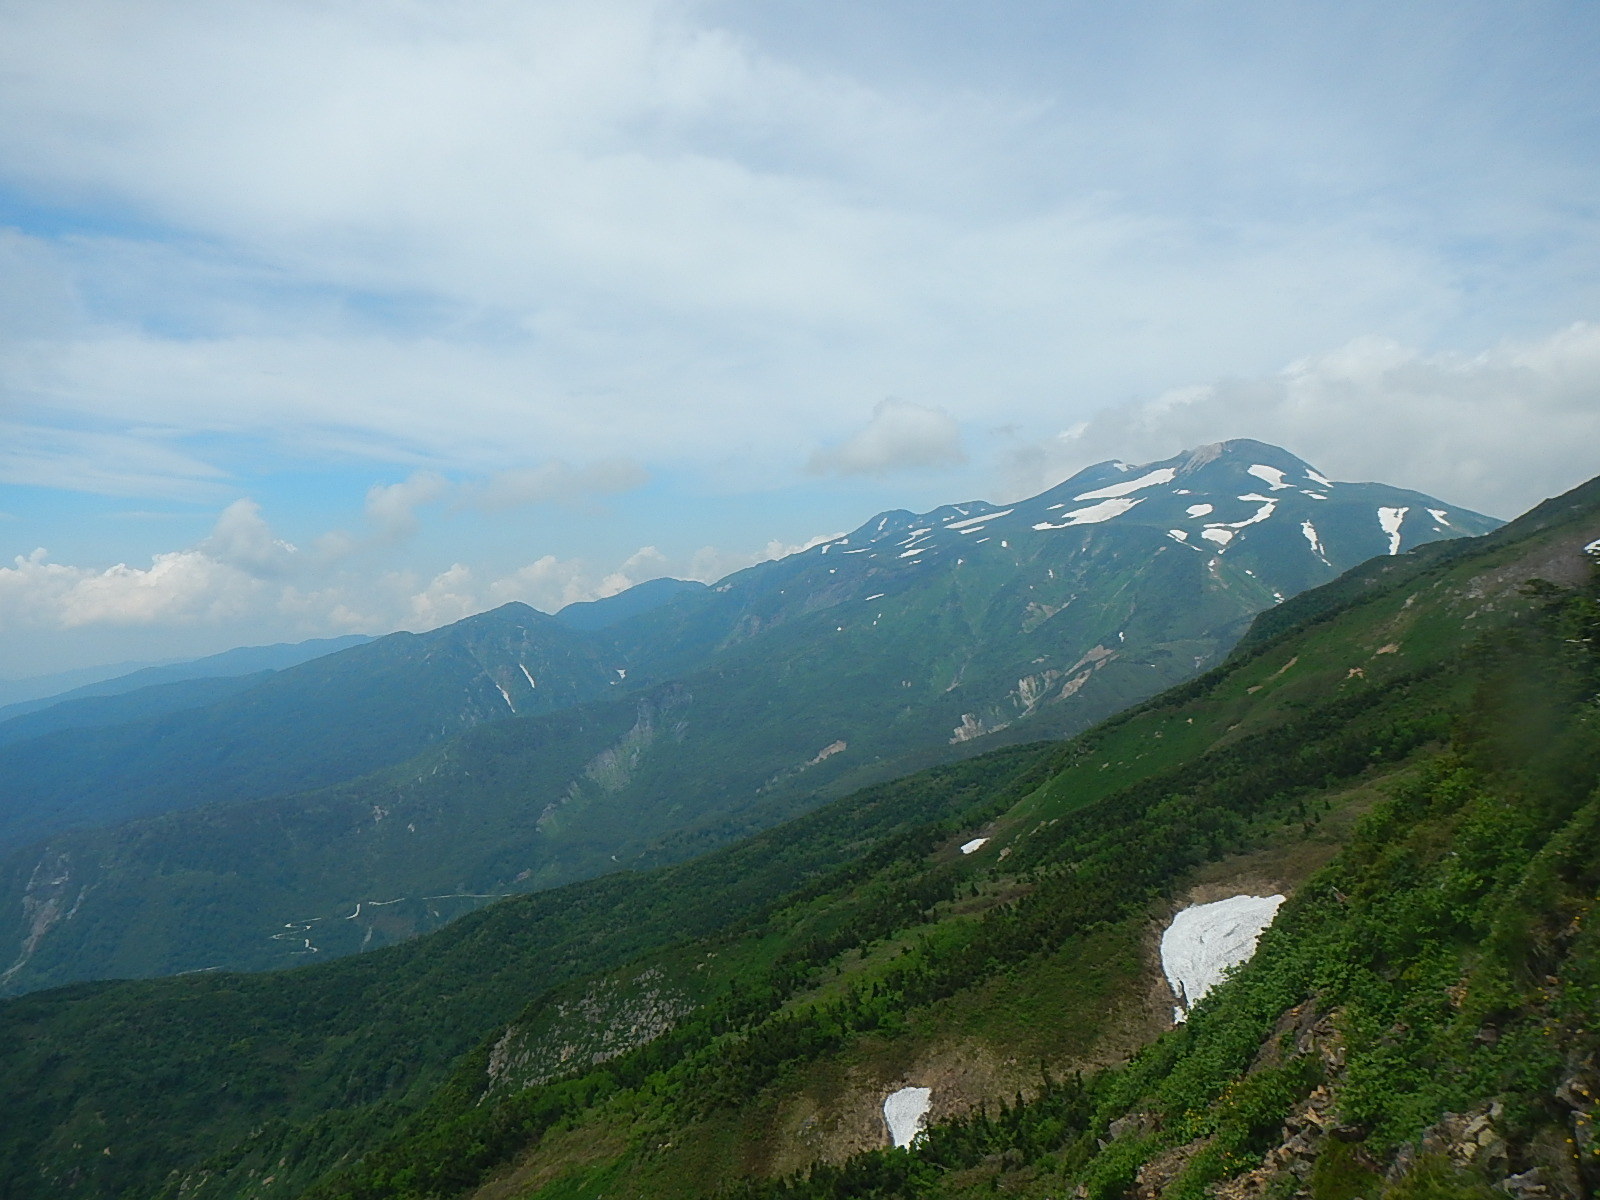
[0, 0, 1600, 678]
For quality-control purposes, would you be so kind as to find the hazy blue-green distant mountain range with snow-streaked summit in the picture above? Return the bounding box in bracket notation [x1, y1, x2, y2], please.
[0, 442, 1498, 990]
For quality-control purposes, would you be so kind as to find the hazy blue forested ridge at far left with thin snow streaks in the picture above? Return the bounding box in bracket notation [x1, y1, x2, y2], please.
[0, 605, 618, 850]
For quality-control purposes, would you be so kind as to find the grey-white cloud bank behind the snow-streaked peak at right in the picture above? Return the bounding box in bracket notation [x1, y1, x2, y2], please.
[1011, 323, 1600, 517]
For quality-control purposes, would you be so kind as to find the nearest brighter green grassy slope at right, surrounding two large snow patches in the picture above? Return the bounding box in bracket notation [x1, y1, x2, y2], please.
[288, 476, 1600, 1198]
